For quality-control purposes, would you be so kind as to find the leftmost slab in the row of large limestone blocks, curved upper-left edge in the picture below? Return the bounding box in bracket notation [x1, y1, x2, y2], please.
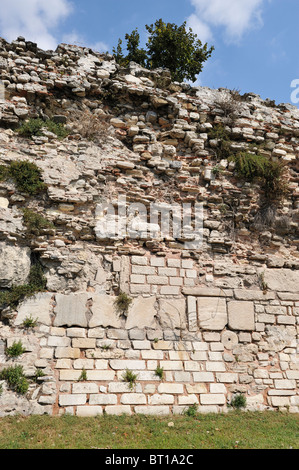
[14, 292, 53, 326]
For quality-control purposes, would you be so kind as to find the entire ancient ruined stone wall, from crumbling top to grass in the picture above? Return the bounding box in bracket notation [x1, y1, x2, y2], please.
[0, 38, 299, 416]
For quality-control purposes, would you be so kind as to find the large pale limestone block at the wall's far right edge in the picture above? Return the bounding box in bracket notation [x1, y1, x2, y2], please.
[264, 269, 299, 292]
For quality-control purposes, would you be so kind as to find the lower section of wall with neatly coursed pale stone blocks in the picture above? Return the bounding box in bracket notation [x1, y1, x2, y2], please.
[0, 256, 299, 416]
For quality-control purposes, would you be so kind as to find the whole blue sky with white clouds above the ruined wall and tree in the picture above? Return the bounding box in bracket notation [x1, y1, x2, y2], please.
[0, 0, 299, 104]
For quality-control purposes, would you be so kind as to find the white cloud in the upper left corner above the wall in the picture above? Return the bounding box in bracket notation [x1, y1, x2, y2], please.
[0, 0, 72, 49]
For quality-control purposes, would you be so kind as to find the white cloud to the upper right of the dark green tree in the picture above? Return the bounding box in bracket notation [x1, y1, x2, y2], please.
[187, 0, 269, 42]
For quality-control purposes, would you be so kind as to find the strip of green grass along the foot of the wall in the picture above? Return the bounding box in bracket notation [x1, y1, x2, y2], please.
[0, 411, 299, 450]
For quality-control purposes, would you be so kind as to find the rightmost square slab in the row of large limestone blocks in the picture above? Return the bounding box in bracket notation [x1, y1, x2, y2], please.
[228, 300, 255, 331]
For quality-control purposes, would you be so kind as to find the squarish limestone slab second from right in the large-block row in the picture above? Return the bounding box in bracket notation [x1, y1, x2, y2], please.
[197, 297, 227, 331]
